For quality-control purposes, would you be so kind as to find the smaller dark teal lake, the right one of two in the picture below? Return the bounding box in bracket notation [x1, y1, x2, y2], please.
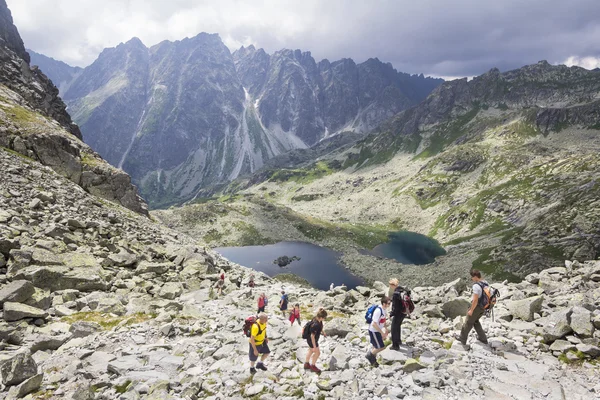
[369, 231, 446, 265]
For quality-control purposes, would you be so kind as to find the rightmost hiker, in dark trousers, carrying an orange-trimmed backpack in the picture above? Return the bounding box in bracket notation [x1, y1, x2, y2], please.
[456, 269, 500, 345]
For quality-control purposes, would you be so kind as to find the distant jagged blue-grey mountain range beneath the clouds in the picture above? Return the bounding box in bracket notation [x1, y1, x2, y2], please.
[27, 37, 443, 206]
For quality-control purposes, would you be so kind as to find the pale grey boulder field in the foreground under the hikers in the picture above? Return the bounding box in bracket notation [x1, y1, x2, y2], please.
[0, 145, 600, 400]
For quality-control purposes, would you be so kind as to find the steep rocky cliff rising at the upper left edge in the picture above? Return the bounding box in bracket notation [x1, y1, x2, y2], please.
[0, 1, 148, 215]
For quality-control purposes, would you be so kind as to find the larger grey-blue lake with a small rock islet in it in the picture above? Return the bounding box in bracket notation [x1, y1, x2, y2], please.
[214, 242, 363, 290]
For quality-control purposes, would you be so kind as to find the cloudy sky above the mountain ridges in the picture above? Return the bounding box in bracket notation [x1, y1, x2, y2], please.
[7, 0, 600, 78]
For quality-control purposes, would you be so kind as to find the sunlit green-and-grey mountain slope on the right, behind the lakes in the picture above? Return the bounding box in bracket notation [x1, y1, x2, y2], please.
[156, 62, 600, 282]
